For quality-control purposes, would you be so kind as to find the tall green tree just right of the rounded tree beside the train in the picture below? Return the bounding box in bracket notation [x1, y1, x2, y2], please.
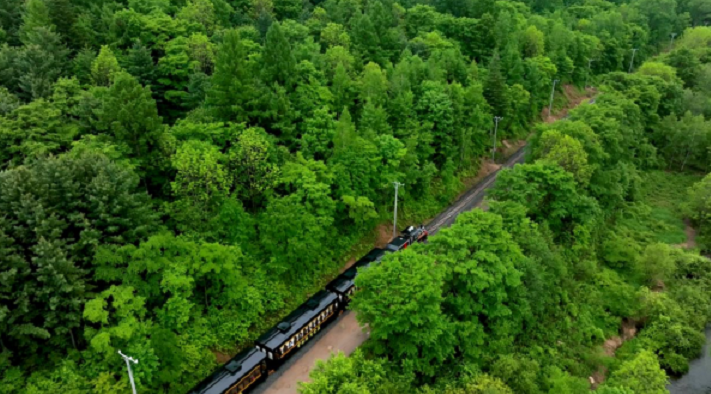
[427, 210, 524, 362]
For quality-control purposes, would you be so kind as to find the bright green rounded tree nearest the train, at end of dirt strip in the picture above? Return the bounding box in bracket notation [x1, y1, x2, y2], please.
[351, 248, 455, 376]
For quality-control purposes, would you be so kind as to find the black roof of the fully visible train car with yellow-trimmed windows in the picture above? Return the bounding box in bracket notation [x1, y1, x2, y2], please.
[257, 290, 338, 349]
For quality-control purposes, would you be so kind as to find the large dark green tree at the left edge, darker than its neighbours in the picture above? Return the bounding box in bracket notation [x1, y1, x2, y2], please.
[0, 155, 156, 357]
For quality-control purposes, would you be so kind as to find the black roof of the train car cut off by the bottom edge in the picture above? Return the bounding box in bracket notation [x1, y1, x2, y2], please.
[188, 347, 266, 394]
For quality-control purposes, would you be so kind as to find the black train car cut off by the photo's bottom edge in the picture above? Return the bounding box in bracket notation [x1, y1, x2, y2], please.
[188, 347, 267, 394]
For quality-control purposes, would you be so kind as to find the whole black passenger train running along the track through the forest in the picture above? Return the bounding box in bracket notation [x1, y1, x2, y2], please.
[188, 226, 429, 394]
